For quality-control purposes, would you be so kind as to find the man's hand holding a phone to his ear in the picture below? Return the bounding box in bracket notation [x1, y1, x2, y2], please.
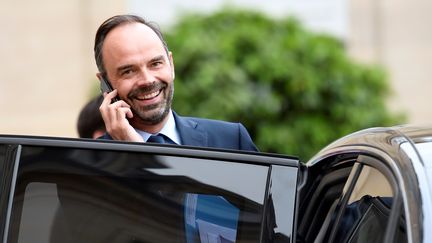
[99, 89, 144, 142]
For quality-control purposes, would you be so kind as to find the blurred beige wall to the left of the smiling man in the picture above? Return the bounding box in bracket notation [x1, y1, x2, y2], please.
[0, 0, 126, 137]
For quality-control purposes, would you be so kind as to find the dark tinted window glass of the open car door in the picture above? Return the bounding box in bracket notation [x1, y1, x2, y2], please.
[8, 147, 269, 243]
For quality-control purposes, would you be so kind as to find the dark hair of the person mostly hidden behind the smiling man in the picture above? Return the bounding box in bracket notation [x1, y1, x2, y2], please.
[77, 95, 105, 138]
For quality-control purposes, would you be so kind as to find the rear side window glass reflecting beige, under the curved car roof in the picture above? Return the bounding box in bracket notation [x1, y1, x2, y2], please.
[335, 165, 406, 243]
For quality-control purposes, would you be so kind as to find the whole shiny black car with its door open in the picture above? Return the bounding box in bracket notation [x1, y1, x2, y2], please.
[0, 124, 432, 243]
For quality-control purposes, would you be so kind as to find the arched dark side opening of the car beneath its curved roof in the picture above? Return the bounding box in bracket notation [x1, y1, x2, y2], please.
[298, 155, 407, 243]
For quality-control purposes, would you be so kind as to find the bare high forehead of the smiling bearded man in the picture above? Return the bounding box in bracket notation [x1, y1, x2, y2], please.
[102, 23, 165, 64]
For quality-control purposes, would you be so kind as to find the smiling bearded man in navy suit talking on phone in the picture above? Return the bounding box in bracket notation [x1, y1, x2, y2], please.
[94, 15, 257, 151]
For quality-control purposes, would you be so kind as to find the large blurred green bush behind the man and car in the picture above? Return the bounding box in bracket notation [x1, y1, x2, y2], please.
[165, 8, 401, 161]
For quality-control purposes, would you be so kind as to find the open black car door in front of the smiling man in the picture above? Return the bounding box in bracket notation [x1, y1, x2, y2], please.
[0, 136, 299, 243]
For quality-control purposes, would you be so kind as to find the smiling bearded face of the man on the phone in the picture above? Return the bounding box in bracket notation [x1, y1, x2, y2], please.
[102, 23, 174, 125]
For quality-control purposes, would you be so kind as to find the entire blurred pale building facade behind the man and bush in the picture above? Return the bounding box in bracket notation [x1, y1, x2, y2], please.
[0, 0, 432, 137]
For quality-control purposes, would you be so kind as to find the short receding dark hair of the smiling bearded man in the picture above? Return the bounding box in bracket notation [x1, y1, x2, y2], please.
[94, 14, 169, 74]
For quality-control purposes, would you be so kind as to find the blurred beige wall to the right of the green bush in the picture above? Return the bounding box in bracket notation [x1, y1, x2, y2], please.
[347, 0, 432, 125]
